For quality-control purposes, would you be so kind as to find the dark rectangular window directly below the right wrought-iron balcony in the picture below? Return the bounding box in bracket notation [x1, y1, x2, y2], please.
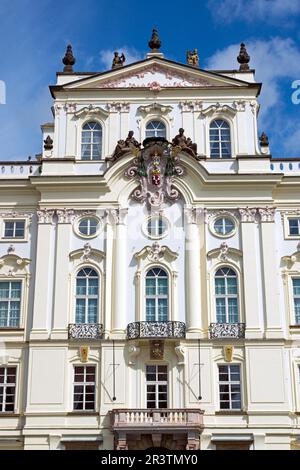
[219, 364, 242, 410]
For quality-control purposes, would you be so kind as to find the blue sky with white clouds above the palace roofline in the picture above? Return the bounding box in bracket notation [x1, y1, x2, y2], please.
[0, 0, 300, 160]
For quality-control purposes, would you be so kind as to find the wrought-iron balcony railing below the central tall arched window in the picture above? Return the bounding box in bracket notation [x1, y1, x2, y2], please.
[127, 321, 185, 339]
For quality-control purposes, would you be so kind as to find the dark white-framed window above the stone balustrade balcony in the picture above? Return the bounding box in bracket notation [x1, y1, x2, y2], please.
[146, 364, 168, 409]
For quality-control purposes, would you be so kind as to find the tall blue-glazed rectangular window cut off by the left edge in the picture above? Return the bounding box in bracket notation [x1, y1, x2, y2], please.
[0, 281, 22, 328]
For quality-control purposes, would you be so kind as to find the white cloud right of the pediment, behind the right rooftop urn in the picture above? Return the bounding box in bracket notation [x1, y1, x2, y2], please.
[207, 37, 300, 154]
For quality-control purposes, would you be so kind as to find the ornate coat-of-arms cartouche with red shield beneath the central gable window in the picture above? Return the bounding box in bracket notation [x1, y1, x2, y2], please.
[125, 138, 184, 209]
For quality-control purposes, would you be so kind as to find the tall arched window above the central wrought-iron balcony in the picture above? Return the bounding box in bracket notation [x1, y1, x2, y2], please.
[146, 268, 169, 321]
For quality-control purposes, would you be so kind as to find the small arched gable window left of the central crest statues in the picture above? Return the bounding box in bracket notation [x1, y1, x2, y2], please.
[81, 121, 102, 160]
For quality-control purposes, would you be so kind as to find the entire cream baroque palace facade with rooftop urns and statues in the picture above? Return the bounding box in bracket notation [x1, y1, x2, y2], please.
[0, 30, 300, 450]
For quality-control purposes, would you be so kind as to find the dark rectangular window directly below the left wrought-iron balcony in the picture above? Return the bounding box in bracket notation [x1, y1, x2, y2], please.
[73, 366, 96, 411]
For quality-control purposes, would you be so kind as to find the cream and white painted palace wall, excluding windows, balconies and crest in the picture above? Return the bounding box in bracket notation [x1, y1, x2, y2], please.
[0, 58, 300, 449]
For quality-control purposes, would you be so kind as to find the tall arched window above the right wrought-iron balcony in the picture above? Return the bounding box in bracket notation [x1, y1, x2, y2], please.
[215, 266, 239, 323]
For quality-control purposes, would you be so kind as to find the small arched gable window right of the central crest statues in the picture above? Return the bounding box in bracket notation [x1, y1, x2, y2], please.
[209, 119, 231, 158]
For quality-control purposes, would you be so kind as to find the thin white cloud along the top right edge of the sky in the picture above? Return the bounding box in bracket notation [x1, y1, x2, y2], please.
[207, 0, 300, 25]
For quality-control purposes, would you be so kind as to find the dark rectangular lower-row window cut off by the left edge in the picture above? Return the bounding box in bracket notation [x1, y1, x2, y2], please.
[0, 367, 17, 413]
